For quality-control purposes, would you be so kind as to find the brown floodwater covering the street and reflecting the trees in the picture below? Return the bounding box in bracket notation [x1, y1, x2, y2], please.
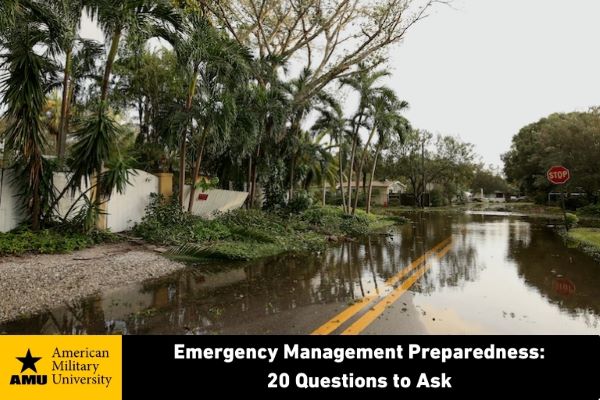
[0, 213, 600, 334]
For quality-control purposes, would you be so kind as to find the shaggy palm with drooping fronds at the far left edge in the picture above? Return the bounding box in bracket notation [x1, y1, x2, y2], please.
[0, 18, 55, 230]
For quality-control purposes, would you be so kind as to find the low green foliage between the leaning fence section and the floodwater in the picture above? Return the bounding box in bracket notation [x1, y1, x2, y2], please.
[133, 202, 398, 260]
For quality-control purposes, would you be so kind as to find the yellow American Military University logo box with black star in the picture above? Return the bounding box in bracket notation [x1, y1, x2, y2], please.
[0, 336, 123, 400]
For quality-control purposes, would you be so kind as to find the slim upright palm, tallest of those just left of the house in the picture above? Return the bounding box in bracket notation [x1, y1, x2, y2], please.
[340, 64, 390, 212]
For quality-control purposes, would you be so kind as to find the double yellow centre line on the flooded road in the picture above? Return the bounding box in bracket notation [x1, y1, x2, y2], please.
[312, 237, 452, 335]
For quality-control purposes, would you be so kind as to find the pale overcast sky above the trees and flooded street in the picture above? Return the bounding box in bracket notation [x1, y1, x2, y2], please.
[82, 0, 600, 167]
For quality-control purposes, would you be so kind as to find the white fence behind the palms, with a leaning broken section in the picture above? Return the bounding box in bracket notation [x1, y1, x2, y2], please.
[0, 168, 248, 232]
